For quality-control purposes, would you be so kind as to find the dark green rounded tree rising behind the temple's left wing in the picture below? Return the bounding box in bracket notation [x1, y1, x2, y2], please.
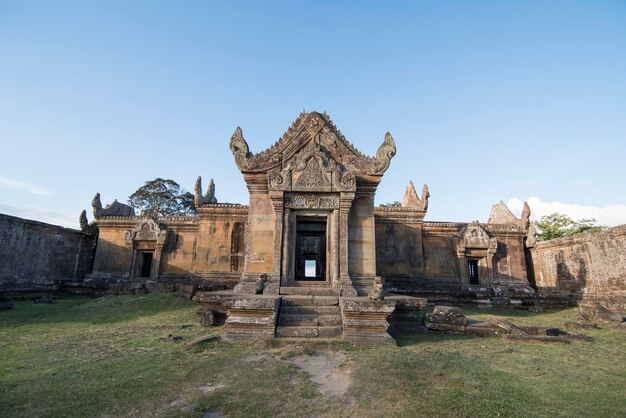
[128, 177, 196, 216]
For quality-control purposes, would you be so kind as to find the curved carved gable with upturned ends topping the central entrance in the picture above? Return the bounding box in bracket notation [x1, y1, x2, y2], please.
[230, 112, 396, 176]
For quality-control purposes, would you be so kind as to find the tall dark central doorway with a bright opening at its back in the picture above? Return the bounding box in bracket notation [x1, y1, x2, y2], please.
[296, 218, 326, 281]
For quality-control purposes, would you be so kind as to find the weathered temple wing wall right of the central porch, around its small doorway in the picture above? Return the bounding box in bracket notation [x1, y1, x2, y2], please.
[376, 219, 531, 292]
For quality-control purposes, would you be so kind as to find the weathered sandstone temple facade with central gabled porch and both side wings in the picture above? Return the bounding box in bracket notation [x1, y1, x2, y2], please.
[81, 112, 532, 298]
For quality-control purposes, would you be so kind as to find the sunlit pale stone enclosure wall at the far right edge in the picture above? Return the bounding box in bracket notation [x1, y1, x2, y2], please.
[531, 225, 626, 312]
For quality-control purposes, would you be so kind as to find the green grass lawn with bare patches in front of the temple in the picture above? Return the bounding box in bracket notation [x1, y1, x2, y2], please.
[0, 294, 626, 417]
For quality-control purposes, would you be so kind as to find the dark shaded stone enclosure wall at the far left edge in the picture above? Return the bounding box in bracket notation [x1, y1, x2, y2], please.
[0, 214, 96, 289]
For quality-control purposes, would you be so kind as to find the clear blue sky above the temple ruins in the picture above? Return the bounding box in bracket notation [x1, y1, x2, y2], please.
[0, 0, 626, 226]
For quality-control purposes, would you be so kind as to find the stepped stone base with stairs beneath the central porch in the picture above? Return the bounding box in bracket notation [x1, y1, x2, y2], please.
[193, 288, 426, 344]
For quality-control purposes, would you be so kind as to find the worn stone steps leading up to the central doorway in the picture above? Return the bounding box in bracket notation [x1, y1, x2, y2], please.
[276, 288, 343, 338]
